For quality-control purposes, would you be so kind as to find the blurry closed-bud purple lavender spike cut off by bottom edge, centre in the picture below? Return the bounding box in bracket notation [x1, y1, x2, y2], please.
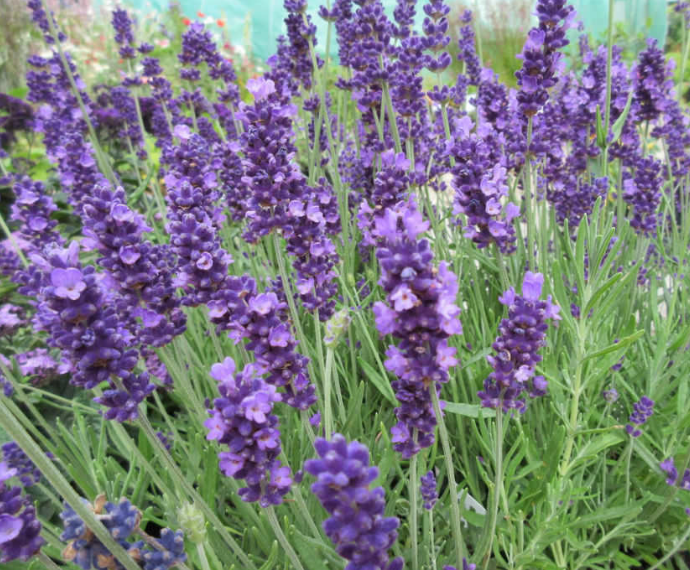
[304, 434, 403, 570]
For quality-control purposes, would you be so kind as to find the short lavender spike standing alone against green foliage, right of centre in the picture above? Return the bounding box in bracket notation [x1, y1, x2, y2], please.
[478, 271, 561, 413]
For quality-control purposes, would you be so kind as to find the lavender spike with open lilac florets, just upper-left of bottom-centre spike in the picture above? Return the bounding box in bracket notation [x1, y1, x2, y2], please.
[204, 357, 292, 507]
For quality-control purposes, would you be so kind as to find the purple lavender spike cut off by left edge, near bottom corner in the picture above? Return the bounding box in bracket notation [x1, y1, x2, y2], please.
[0, 461, 45, 564]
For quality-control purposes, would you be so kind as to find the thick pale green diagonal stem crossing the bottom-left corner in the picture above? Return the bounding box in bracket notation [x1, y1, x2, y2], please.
[0, 398, 141, 570]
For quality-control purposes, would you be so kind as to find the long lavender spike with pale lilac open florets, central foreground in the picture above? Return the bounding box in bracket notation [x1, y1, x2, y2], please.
[373, 199, 462, 457]
